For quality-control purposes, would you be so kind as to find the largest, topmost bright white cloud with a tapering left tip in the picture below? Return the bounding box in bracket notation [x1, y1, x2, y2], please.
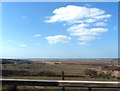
[46, 5, 111, 23]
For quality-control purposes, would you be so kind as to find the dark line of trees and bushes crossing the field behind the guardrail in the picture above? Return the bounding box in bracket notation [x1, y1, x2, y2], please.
[2, 69, 111, 79]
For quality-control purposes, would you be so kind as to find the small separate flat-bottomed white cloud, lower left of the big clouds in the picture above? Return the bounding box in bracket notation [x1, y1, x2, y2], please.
[45, 35, 71, 44]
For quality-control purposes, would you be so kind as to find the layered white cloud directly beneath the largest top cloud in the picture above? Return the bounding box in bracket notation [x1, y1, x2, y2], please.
[68, 24, 108, 42]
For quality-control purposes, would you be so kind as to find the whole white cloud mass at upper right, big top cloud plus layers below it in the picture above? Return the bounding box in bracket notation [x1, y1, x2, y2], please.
[45, 5, 111, 45]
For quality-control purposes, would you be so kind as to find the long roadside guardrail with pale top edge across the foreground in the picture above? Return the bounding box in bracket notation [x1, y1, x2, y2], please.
[0, 79, 120, 91]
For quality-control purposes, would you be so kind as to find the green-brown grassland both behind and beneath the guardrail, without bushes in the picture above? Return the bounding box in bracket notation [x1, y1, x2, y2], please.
[2, 60, 119, 91]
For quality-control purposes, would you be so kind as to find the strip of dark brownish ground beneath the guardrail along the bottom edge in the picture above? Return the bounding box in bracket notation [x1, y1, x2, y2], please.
[1, 86, 120, 91]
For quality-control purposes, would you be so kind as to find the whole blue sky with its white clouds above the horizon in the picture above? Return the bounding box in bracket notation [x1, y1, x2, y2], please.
[0, 2, 118, 58]
